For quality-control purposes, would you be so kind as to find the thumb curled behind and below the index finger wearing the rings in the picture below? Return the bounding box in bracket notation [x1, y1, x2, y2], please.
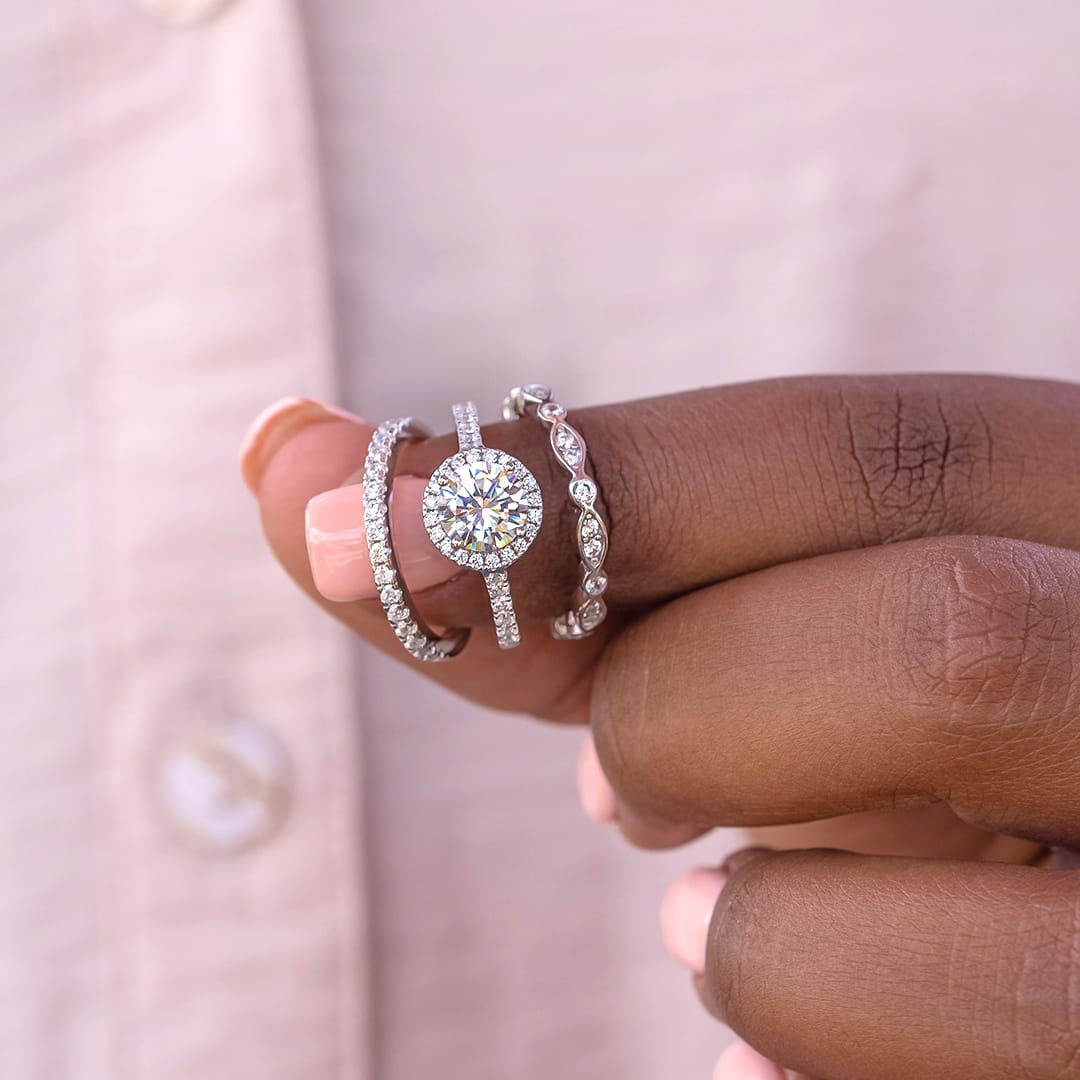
[245, 401, 610, 723]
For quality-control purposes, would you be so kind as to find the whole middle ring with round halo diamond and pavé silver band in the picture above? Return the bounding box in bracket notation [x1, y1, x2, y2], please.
[423, 402, 543, 649]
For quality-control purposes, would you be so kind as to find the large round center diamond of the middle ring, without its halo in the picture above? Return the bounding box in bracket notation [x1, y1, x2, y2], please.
[434, 459, 529, 555]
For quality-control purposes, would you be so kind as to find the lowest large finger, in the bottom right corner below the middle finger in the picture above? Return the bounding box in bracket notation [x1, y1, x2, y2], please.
[669, 851, 1080, 1080]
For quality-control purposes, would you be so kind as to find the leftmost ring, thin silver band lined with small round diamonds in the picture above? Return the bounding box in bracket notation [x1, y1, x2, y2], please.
[364, 417, 469, 663]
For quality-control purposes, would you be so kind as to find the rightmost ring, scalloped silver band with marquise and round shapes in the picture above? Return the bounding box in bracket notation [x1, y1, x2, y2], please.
[502, 383, 608, 639]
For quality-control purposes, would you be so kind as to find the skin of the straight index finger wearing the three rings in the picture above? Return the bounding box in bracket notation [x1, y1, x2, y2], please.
[262, 376, 1080, 625]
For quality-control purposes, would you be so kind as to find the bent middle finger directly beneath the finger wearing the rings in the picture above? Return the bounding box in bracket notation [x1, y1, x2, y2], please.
[592, 538, 1080, 846]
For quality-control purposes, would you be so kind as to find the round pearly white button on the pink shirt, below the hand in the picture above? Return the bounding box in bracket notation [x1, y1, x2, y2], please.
[153, 716, 293, 854]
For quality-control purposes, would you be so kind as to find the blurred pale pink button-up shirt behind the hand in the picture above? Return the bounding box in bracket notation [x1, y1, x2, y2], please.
[6, 0, 1080, 1080]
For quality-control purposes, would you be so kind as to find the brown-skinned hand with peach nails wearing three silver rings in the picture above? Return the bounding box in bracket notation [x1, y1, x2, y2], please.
[248, 376, 1080, 1080]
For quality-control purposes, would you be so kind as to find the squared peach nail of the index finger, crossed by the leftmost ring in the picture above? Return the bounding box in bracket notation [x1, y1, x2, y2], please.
[306, 476, 461, 602]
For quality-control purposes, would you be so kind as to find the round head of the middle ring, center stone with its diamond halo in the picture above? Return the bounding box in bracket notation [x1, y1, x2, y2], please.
[423, 447, 543, 571]
